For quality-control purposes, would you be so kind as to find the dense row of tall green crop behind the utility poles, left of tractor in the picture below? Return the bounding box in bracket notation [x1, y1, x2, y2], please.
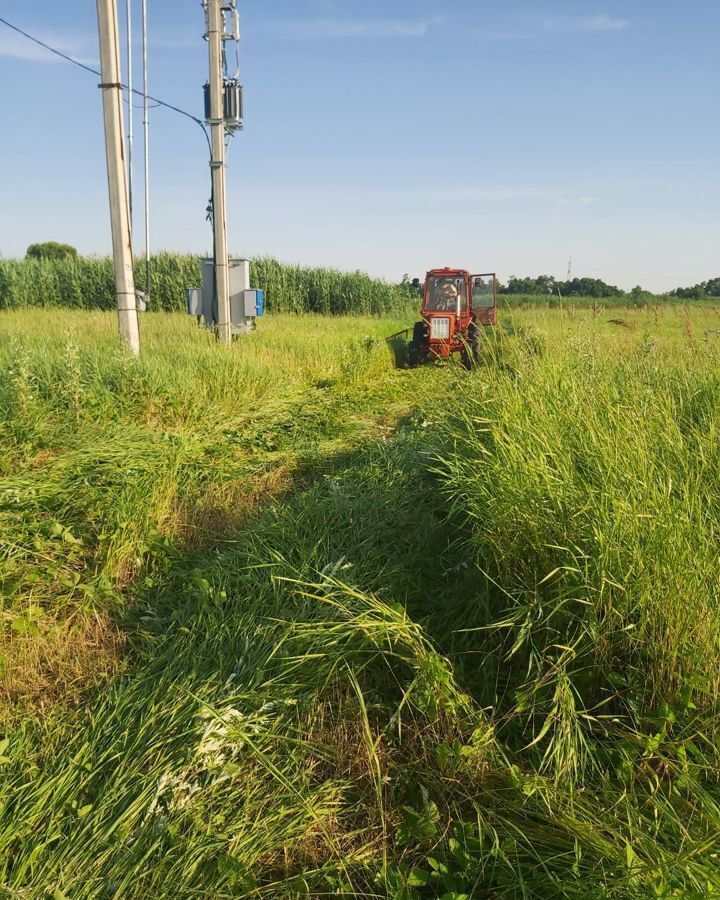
[0, 253, 416, 315]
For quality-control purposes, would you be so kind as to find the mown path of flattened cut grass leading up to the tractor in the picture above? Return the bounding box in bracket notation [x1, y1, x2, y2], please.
[0, 326, 478, 897]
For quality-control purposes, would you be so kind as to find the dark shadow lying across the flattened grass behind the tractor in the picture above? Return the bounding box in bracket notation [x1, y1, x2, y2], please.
[121, 413, 497, 702]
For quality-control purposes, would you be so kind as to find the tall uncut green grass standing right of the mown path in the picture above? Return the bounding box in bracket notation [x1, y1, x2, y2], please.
[435, 317, 720, 760]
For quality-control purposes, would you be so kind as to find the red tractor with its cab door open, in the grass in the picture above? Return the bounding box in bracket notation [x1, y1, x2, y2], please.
[408, 269, 497, 368]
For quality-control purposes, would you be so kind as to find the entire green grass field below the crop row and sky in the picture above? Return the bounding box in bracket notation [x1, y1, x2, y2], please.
[0, 307, 720, 900]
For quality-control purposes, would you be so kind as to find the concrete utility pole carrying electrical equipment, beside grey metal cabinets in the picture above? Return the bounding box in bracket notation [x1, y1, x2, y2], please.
[207, 0, 232, 345]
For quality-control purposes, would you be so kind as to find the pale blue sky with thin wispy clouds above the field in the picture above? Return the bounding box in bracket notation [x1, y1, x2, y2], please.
[0, 0, 720, 290]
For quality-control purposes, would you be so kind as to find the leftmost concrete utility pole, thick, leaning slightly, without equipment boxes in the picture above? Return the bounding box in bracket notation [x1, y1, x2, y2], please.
[97, 0, 140, 355]
